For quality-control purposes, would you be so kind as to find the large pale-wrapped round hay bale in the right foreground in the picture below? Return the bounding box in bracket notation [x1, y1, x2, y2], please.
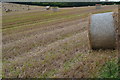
[89, 12, 116, 49]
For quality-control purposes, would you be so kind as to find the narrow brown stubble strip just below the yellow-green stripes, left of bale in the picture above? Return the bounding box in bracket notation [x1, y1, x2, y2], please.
[3, 18, 87, 45]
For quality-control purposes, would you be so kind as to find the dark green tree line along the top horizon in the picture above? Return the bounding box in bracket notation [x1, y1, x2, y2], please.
[11, 2, 118, 7]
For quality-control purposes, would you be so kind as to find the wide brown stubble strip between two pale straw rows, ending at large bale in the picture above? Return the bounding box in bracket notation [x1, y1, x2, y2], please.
[3, 18, 88, 58]
